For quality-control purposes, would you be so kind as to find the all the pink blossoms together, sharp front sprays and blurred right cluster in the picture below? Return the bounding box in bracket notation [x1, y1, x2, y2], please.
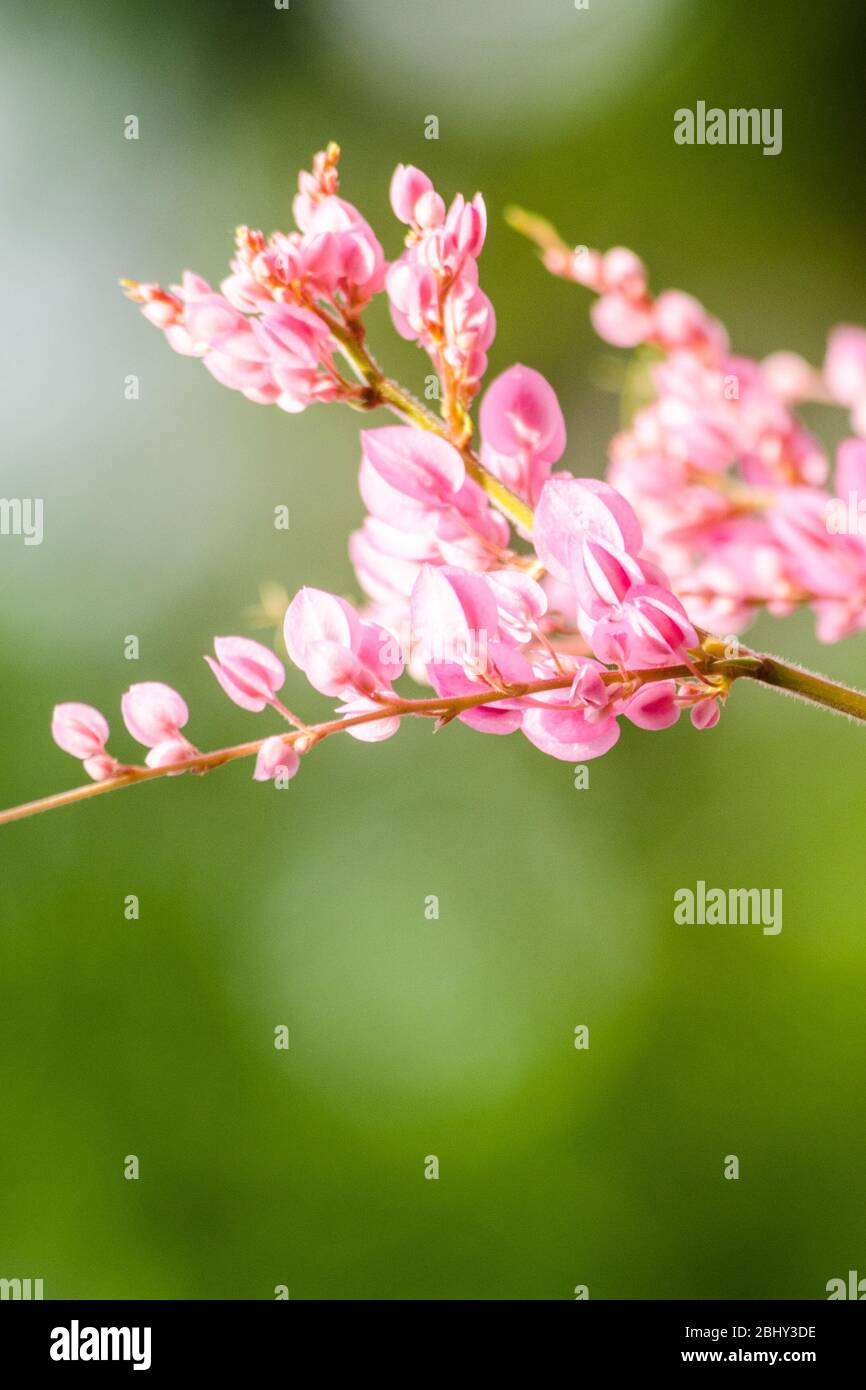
[44, 146, 866, 800]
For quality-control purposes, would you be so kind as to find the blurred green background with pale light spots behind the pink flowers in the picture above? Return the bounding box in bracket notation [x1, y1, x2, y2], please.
[0, 0, 866, 1300]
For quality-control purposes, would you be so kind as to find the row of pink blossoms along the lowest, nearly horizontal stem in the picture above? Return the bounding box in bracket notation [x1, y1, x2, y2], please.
[51, 455, 724, 781]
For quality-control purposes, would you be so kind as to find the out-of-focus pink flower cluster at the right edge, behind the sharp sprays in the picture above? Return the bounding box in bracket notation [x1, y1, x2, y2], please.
[545, 247, 866, 641]
